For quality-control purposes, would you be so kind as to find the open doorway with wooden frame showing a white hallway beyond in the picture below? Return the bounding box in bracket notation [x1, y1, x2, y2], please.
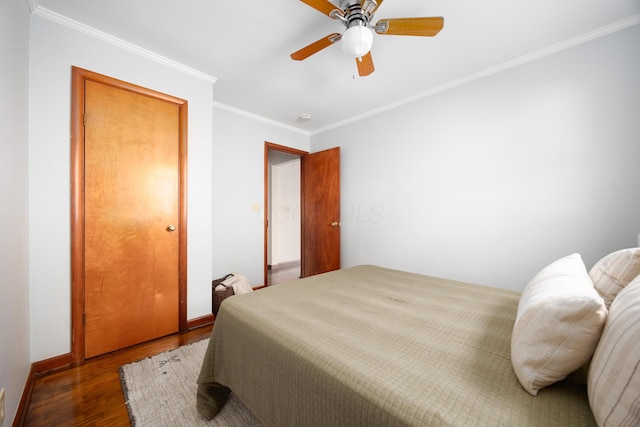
[265, 142, 307, 286]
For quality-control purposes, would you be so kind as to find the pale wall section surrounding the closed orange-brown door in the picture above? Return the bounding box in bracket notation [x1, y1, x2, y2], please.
[29, 16, 213, 361]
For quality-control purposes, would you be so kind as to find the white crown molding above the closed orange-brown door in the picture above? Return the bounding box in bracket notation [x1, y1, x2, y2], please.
[29, 0, 218, 84]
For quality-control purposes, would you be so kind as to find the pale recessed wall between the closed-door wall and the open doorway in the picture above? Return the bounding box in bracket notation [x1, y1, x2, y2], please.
[212, 106, 309, 286]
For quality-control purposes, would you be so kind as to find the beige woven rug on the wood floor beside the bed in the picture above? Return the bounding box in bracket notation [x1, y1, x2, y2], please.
[120, 339, 260, 427]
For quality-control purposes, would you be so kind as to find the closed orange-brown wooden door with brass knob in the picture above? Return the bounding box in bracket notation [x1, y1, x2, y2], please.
[83, 76, 182, 358]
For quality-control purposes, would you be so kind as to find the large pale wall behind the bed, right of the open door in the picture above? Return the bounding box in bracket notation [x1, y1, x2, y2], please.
[311, 25, 640, 290]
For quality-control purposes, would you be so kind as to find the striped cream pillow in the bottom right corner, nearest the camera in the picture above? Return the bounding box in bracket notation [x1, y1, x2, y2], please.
[587, 277, 640, 427]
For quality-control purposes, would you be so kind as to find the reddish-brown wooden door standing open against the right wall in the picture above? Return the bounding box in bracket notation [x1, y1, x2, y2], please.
[301, 147, 340, 277]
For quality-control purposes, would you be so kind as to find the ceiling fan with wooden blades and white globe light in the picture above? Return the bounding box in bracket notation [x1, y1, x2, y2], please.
[291, 0, 444, 76]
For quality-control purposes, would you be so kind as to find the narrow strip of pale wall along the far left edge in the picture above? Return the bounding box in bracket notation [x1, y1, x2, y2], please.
[0, 0, 29, 425]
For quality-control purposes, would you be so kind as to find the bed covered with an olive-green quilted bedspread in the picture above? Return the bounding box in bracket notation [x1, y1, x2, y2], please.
[197, 252, 640, 426]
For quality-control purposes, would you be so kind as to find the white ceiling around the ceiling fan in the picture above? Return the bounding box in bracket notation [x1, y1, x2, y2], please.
[30, 0, 640, 132]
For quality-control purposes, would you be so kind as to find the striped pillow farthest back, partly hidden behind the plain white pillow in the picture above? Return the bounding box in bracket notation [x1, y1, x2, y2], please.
[589, 248, 640, 308]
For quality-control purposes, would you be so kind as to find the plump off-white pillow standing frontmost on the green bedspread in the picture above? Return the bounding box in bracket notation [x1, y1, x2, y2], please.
[511, 254, 607, 396]
